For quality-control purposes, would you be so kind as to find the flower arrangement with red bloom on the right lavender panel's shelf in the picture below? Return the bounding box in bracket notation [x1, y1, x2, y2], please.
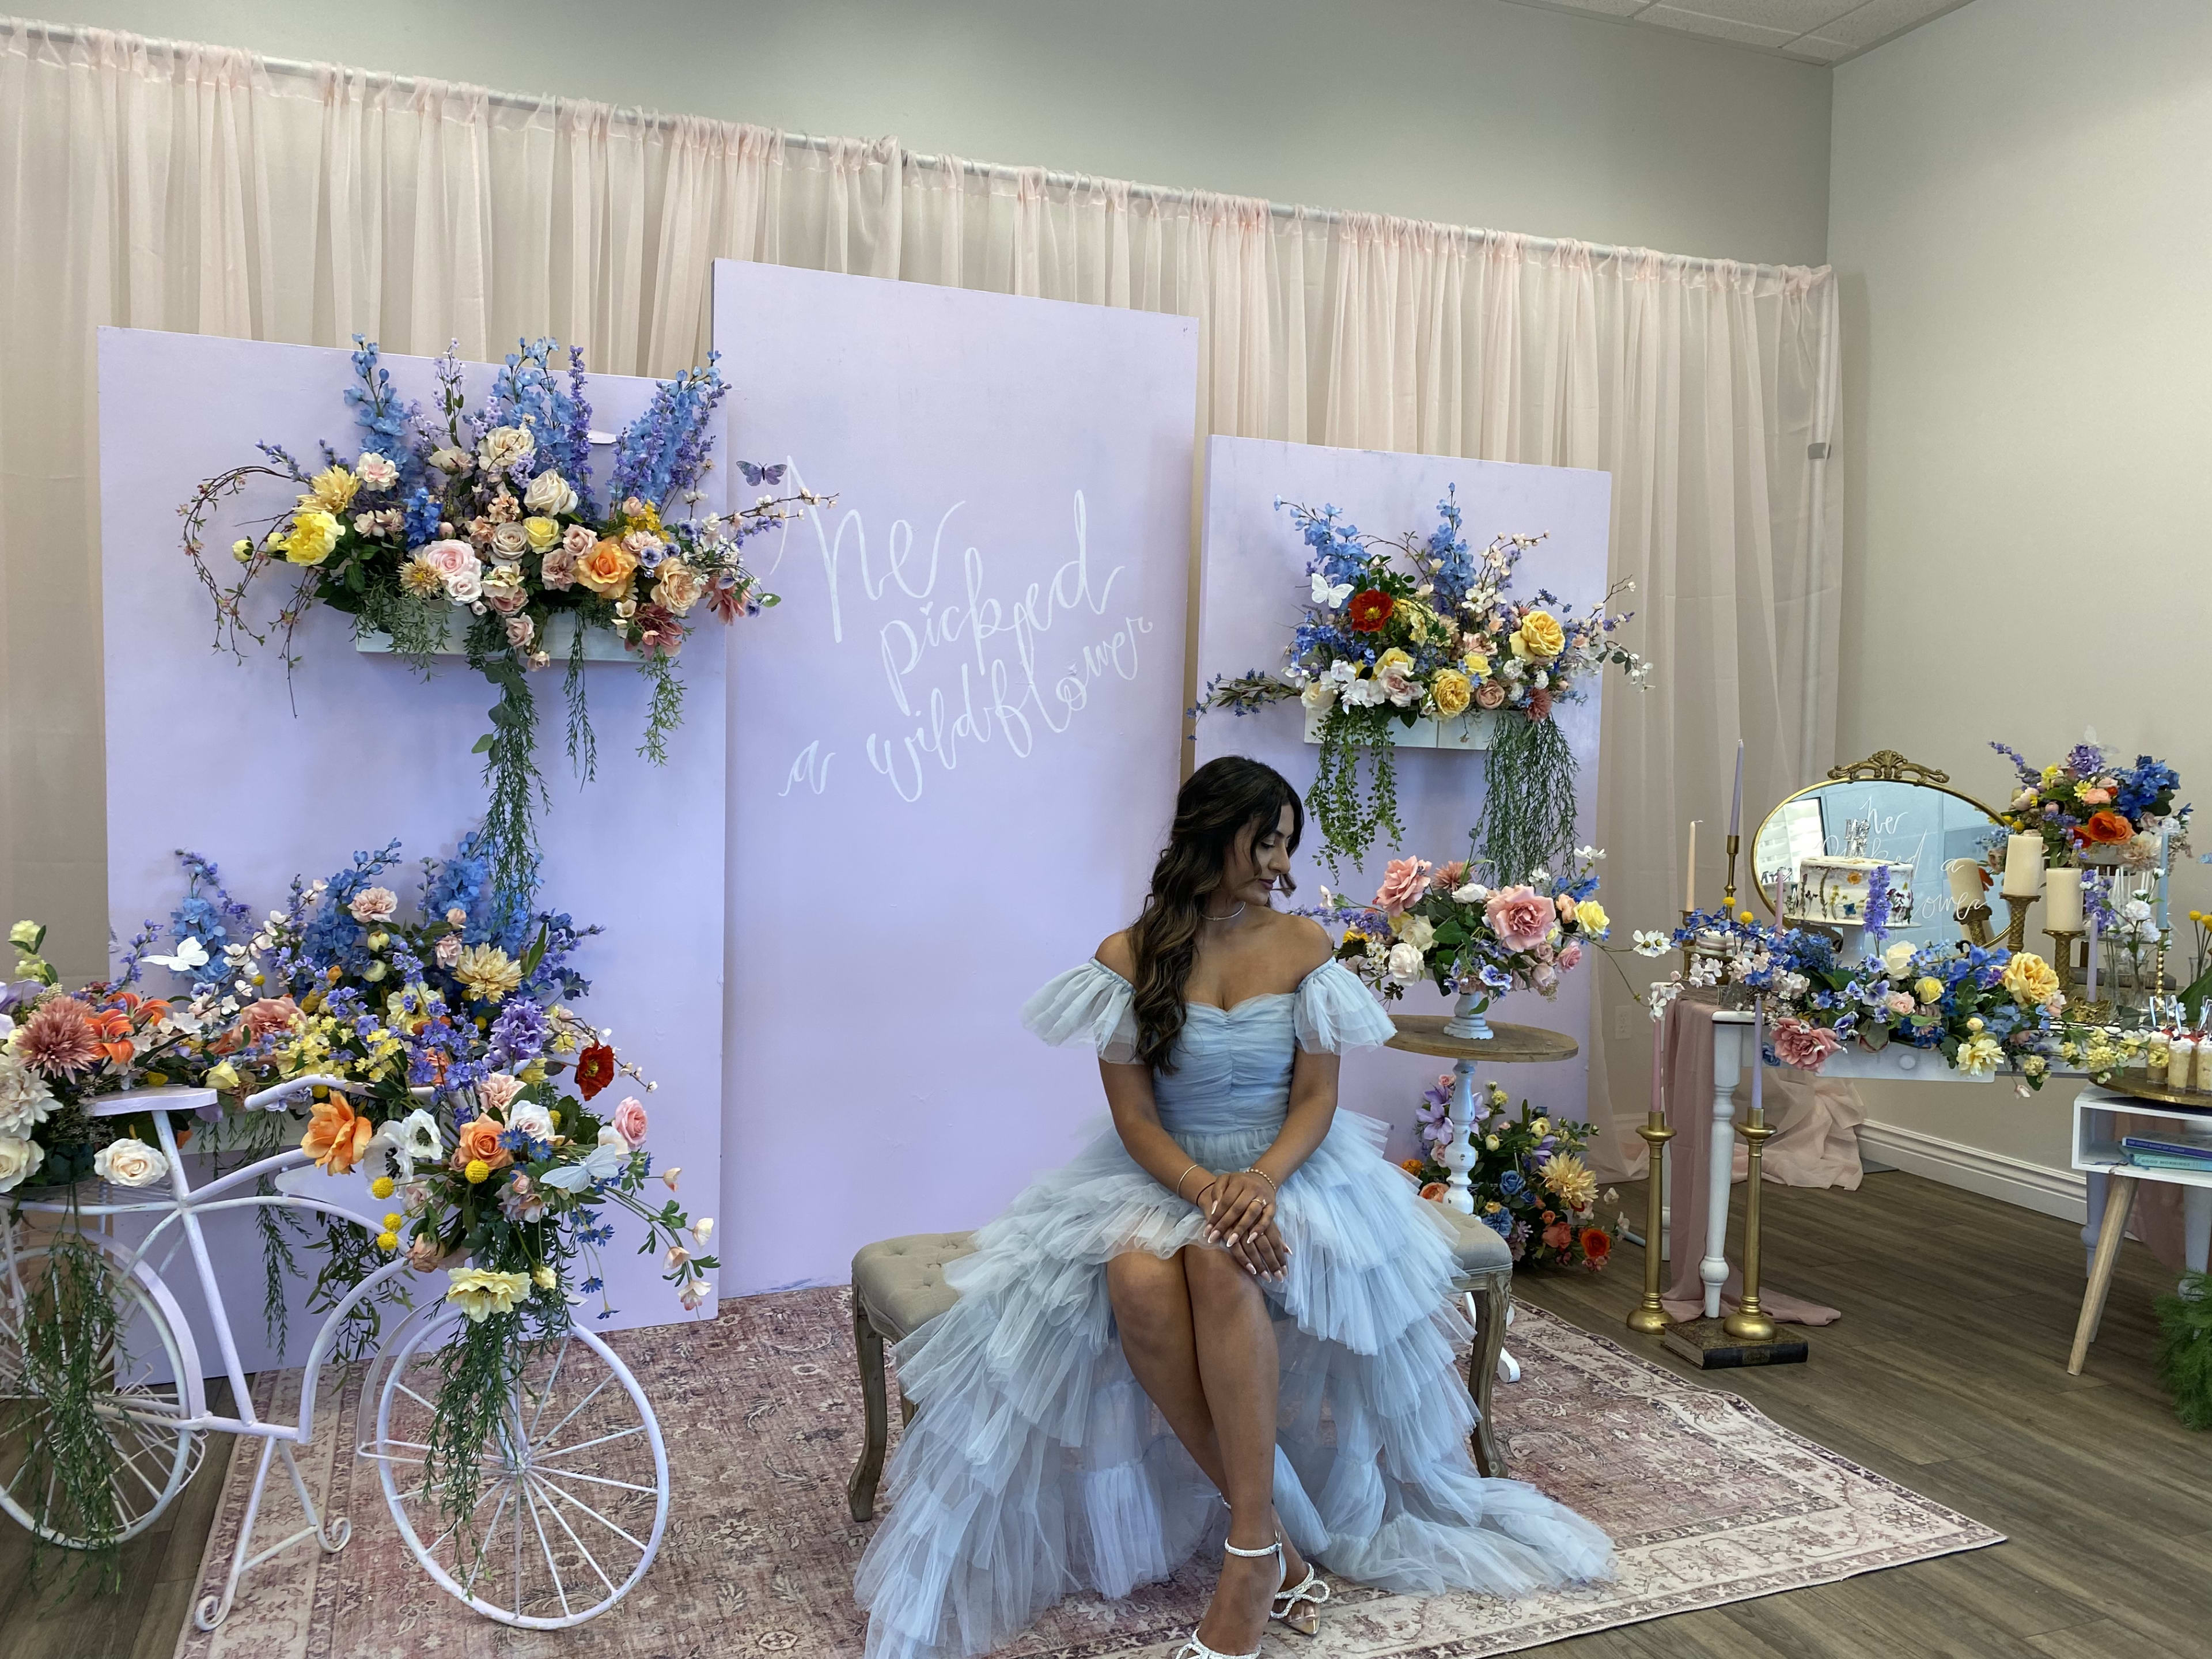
[1199, 493, 1650, 876]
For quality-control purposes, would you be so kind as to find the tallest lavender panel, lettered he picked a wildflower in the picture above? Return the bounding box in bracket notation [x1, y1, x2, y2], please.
[714, 263, 1196, 1294]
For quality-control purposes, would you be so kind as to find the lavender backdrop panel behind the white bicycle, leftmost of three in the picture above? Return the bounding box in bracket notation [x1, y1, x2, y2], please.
[100, 329, 728, 1367]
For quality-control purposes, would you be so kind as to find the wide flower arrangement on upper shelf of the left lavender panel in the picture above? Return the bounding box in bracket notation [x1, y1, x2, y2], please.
[179, 336, 821, 911]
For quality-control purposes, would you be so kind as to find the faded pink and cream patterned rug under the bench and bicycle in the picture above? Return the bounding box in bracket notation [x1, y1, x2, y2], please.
[177, 1290, 2002, 1659]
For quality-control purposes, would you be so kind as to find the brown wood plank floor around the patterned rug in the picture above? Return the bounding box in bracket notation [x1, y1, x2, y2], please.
[0, 1175, 2212, 1659]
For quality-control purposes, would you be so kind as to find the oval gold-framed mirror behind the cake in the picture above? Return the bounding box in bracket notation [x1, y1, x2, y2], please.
[1749, 750, 2004, 953]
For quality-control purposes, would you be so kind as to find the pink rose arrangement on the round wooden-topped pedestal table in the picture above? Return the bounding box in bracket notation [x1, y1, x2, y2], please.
[1309, 847, 1612, 1022]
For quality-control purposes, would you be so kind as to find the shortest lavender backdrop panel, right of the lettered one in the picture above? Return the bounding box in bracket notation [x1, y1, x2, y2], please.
[1196, 438, 1612, 1157]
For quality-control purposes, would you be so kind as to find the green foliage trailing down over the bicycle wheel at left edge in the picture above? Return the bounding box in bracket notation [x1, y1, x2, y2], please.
[0, 1217, 122, 1593]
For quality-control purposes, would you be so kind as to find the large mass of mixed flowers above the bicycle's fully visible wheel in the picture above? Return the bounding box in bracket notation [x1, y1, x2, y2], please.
[123, 832, 719, 1548]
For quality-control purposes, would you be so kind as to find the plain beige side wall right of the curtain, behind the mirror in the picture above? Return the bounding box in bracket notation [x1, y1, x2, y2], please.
[1830, 0, 2212, 1183]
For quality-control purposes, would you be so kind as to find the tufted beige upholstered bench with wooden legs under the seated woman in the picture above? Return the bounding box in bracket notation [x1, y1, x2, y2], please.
[845, 1203, 1513, 1522]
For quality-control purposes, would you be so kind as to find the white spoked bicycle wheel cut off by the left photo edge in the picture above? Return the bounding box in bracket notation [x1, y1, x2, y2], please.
[0, 1241, 206, 1548]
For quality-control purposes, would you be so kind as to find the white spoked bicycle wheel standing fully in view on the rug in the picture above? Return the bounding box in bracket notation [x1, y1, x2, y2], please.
[361, 1307, 668, 1630]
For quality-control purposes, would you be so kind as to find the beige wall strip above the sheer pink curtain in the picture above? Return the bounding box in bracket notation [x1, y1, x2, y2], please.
[24, 0, 1830, 266]
